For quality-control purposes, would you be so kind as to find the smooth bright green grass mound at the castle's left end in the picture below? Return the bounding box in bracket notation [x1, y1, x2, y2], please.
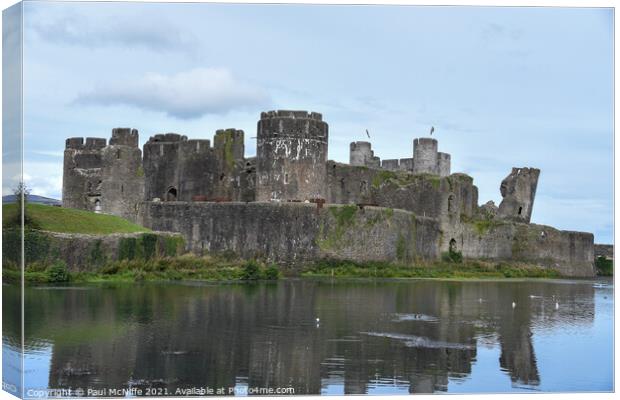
[2, 204, 150, 234]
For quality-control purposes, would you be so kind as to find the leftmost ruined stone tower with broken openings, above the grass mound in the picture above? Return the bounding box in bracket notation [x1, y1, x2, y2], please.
[62, 137, 106, 211]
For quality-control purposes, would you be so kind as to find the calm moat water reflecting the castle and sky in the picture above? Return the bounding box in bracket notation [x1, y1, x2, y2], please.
[2, 279, 613, 397]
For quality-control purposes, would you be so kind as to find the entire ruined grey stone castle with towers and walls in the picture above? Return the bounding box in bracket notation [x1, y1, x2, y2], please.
[63, 110, 594, 276]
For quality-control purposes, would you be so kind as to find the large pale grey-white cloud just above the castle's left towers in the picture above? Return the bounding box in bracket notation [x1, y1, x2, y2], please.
[75, 68, 270, 119]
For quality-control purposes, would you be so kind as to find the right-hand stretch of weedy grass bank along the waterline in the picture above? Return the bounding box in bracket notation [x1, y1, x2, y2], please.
[302, 261, 560, 279]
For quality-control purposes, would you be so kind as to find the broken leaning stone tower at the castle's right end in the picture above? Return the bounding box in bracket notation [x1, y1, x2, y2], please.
[498, 168, 540, 223]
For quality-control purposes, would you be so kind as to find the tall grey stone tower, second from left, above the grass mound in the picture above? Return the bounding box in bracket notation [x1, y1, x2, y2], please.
[100, 128, 144, 221]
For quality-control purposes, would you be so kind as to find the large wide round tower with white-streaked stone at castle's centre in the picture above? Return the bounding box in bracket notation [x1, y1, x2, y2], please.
[256, 110, 328, 201]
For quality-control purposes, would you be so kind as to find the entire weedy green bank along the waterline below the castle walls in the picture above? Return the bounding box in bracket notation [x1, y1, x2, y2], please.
[3, 254, 560, 284]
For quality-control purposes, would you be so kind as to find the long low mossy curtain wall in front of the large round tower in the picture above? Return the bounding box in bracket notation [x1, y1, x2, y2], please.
[141, 202, 439, 264]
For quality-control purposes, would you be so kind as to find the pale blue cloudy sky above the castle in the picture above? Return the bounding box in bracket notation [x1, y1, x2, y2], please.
[4, 2, 613, 242]
